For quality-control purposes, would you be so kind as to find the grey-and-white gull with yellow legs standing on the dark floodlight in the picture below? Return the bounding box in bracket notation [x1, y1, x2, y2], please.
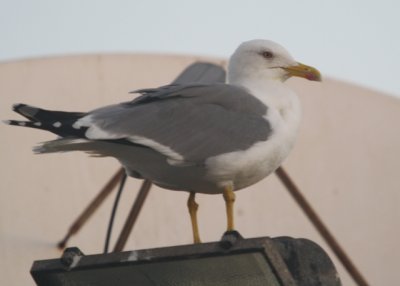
[5, 40, 321, 243]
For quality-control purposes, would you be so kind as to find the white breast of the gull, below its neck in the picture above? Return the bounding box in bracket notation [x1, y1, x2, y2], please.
[206, 83, 301, 190]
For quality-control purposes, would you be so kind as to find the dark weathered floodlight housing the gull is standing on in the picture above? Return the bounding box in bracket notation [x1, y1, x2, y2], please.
[31, 233, 341, 286]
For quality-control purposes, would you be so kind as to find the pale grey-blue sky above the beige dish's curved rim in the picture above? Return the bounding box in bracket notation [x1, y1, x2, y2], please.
[0, 0, 400, 96]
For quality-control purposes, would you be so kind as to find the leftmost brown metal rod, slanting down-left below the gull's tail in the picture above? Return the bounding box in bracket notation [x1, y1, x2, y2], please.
[57, 168, 125, 250]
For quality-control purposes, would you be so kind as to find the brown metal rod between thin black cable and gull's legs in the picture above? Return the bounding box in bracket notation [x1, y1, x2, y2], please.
[113, 180, 152, 252]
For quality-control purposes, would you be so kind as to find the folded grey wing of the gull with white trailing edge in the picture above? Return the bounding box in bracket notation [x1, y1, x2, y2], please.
[75, 84, 271, 164]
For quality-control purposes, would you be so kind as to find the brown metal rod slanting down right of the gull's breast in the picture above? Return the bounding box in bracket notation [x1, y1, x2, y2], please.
[275, 167, 369, 286]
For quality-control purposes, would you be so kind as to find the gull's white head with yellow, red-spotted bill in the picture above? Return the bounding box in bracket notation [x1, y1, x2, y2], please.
[228, 40, 321, 84]
